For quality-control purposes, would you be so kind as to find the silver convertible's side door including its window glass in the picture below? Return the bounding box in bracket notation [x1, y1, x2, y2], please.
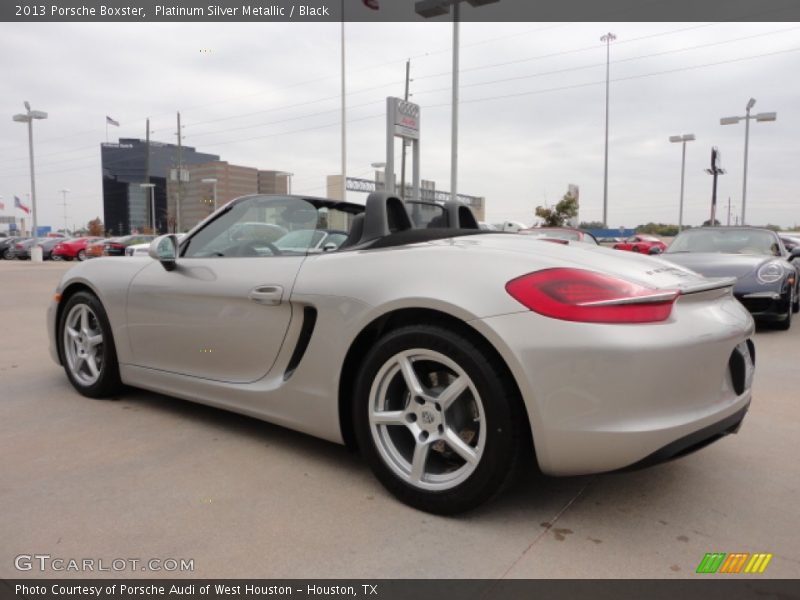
[126, 196, 316, 383]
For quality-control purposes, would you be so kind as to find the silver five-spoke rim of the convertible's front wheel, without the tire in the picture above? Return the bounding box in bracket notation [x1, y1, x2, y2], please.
[62, 304, 103, 386]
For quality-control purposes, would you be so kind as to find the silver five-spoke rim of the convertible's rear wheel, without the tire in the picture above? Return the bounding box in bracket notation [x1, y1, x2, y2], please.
[368, 348, 486, 491]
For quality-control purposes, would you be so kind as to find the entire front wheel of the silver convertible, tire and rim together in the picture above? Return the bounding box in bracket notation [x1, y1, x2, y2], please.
[58, 292, 122, 398]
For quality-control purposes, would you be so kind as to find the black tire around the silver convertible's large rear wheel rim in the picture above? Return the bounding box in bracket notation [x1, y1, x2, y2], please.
[352, 325, 529, 515]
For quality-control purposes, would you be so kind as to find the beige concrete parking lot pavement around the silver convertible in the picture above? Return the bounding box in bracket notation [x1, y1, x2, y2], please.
[0, 258, 800, 578]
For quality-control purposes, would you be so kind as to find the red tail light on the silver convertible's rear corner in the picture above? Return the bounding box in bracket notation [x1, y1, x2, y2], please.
[506, 269, 680, 323]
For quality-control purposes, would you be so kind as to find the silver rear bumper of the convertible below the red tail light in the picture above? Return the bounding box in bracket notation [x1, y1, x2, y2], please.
[472, 291, 753, 475]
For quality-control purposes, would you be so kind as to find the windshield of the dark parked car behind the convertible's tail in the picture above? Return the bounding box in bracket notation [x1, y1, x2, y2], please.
[666, 229, 781, 256]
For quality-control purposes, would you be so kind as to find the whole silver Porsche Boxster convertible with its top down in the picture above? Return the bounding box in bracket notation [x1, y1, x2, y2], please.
[48, 194, 755, 514]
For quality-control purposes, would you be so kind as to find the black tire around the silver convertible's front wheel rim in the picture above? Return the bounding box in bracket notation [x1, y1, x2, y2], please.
[56, 292, 123, 398]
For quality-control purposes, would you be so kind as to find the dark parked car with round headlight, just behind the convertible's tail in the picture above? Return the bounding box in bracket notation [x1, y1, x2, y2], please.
[664, 227, 800, 329]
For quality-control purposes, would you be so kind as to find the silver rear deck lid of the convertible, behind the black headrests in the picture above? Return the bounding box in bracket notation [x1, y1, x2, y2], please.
[432, 234, 733, 292]
